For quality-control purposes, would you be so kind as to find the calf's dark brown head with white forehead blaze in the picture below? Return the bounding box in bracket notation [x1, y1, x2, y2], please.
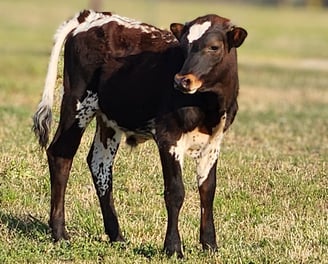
[170, 15, 247, 94]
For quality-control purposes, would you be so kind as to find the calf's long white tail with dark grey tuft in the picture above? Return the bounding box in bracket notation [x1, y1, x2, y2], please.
[32, 16, 79, 148]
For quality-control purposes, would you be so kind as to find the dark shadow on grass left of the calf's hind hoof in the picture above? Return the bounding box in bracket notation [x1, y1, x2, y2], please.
[0, 211, 49, 240]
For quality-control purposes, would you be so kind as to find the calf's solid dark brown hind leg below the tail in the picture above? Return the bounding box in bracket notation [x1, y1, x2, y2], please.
[47, 95, 84, 241]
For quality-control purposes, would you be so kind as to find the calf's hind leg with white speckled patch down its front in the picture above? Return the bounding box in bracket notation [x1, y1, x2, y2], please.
[87, 116, 124, 242]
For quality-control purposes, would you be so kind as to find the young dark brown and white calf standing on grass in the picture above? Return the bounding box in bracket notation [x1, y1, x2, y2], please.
[33, 10, 247, 257]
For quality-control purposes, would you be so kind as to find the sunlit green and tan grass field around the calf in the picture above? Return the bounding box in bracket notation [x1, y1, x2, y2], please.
[0, 0, 328, 263]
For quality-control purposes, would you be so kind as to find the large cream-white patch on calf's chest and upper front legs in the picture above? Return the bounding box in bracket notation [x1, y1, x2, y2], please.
[169, 114, 226, 186]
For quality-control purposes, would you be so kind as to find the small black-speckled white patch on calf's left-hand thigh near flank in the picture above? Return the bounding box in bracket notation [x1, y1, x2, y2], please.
[75, 91, 99, 128]
